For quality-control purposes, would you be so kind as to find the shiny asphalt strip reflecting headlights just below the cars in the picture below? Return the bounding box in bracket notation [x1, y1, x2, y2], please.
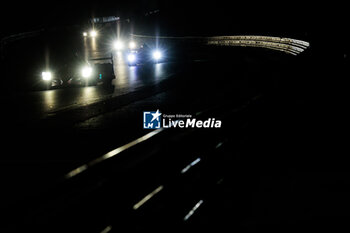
[2, 62, 179, 121]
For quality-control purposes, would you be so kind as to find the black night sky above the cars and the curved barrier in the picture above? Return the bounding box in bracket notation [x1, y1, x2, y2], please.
[0, 0, 342, 48]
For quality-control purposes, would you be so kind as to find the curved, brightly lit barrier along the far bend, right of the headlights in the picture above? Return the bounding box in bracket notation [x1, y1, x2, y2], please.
[131, 34, 310, 55]
